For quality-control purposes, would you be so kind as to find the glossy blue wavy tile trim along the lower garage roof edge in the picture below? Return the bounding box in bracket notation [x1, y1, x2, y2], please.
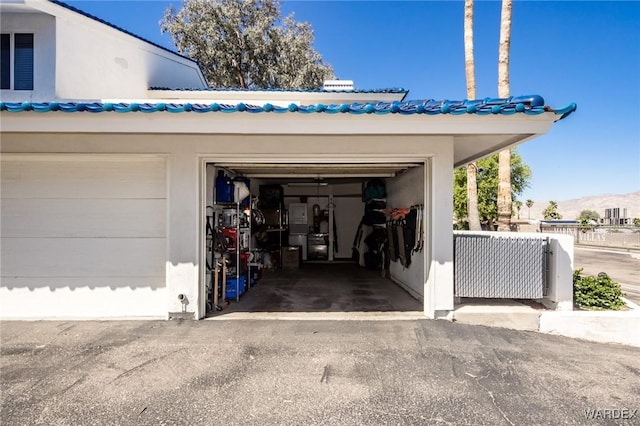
[0, 95, 577, 120]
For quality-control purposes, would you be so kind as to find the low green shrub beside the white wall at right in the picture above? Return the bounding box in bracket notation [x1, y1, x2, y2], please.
[573, 269, 625, 311]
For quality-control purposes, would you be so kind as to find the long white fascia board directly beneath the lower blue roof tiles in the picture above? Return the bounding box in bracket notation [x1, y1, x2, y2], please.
[0, 111, 557, 135]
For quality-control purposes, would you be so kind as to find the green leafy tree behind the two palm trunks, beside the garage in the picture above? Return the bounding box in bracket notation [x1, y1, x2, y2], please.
[453, 149, 531, 230]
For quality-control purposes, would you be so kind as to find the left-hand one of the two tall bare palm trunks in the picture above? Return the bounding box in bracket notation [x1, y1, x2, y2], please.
[464, 0, 482, 231]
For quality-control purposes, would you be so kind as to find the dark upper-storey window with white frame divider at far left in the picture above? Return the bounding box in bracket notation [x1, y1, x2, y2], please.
[0, 34, 34, 90]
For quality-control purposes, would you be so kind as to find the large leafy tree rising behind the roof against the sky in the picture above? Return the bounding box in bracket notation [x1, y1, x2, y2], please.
[160, 0, 334, 89]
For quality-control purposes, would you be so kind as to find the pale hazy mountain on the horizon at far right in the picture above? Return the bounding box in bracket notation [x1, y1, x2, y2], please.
[520, 191, 640, 219]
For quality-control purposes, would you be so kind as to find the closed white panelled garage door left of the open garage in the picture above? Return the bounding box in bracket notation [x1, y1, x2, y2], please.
[0, 154, 167, 318]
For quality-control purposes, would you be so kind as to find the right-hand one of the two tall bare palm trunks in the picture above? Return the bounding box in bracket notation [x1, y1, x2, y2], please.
[498, 0, 513, 231]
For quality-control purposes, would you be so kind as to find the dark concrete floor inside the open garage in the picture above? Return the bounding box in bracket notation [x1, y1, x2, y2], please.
[210, 262, 423, 317]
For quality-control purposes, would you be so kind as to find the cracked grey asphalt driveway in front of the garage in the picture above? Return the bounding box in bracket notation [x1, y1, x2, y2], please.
[0, 320, 640, 426]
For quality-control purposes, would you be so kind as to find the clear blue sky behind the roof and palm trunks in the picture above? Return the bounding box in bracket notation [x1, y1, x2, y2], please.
[68, 0, 640, 201]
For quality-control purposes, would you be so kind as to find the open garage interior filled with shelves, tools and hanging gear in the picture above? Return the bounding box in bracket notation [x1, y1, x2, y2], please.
[202, 160, 428, 317]
